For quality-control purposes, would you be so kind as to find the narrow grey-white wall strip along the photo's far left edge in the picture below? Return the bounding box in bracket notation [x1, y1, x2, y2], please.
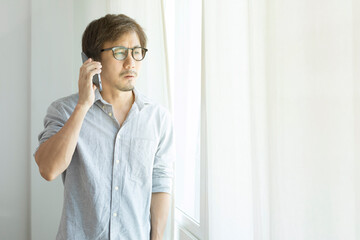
[0, 0, 32, 240]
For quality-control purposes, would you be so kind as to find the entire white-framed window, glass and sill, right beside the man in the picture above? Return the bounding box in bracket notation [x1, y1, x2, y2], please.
[165, 0, 207, 239]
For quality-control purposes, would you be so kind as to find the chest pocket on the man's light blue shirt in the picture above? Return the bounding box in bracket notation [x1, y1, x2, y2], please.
[128, 138, 157, 183]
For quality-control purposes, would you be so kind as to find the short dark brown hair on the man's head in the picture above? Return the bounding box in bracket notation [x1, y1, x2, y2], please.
[82, 14, 147, 61]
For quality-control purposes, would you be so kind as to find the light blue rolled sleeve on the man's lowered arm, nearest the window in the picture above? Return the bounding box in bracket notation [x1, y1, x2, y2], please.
[152, 109, 175, 194]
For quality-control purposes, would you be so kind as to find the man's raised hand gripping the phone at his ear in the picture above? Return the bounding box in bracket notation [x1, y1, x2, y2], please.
[78, 58, 102, 110]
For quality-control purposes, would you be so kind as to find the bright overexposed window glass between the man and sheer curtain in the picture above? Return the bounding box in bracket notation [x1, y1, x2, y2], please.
[173, 0, 201, 223]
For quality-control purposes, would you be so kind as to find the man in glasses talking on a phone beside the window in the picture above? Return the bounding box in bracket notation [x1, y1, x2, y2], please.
[34, 14, 174, 240]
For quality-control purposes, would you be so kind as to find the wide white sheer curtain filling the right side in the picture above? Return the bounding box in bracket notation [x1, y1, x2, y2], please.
[203, 0, 360, 240]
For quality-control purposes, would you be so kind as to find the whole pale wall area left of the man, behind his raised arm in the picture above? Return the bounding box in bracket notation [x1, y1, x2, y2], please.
[0, 0, 106, 240]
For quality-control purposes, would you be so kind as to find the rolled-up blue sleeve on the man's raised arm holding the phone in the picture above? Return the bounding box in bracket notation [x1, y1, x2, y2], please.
[33, 102, 66, 156]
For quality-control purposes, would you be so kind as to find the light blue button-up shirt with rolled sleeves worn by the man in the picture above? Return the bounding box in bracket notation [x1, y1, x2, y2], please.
[34, 89, 175, 240]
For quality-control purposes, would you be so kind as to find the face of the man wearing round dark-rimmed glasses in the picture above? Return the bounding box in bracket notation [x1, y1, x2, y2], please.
[101, 32, 141, 91]
